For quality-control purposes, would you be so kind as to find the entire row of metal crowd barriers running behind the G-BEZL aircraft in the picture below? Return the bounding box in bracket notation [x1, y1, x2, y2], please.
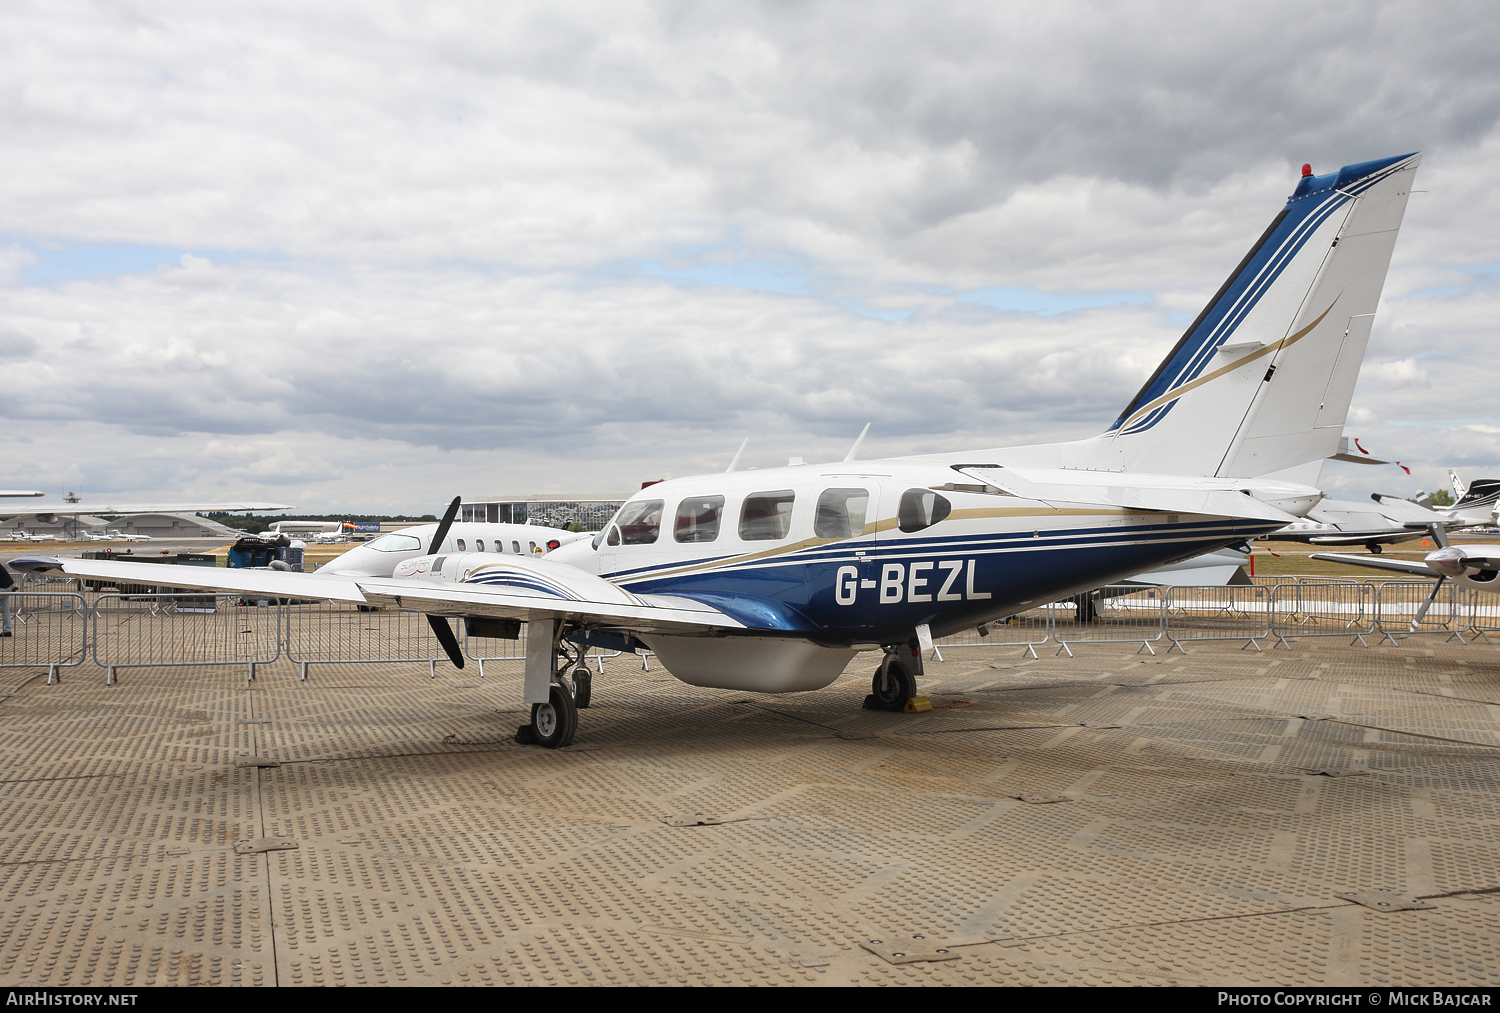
[0, 575, 1500, 684]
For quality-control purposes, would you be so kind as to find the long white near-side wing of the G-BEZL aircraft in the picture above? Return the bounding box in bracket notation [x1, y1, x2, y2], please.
[9, 557, 747, 633]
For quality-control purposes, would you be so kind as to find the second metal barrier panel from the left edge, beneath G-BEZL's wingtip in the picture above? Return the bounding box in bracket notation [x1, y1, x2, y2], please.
[93, 591, 281, 686]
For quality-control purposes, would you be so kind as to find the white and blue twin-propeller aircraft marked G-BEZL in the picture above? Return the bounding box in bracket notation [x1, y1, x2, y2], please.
[27, 155, 1421, 747]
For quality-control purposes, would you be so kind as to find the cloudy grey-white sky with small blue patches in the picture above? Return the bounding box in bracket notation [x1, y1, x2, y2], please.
[0, 0, 1500, 512]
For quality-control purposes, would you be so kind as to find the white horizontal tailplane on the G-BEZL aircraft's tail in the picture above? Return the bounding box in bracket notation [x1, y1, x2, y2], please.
[956, 465, 1298, 524]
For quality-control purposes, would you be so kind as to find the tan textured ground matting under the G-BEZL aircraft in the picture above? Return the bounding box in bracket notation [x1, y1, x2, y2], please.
[0, 638, 1500, 986]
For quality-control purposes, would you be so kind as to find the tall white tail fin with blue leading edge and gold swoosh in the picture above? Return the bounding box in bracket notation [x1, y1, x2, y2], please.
[1092, 153, 1422, 477]
